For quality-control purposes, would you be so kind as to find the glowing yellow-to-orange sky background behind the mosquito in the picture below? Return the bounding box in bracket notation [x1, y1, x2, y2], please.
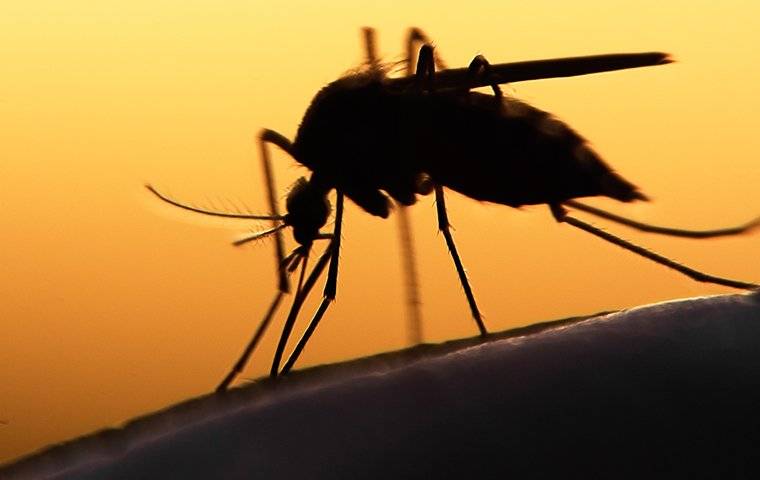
[0, 0, 760, 461]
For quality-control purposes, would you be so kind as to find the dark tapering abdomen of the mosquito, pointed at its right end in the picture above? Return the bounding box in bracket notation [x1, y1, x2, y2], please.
[418, 93, 646, 207]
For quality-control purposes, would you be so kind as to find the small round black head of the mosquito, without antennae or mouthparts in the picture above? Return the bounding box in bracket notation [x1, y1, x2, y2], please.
[285, 177, 330, 245]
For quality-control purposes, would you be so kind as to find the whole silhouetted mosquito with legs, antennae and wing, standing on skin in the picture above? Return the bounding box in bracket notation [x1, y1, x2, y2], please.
[147, 28, 760, 391]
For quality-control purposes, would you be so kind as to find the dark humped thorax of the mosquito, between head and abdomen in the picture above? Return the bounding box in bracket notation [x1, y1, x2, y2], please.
[291, 72, 430, 218]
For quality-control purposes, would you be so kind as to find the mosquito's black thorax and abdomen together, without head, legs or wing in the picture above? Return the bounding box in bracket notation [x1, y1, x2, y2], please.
[291, 56, 645, 218]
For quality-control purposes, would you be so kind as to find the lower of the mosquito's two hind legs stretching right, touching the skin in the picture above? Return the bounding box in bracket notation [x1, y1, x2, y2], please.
[549, 204, 760, 290]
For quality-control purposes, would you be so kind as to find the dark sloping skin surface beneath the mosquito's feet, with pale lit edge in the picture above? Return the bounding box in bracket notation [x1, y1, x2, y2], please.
[0, 293, 760, 479]
